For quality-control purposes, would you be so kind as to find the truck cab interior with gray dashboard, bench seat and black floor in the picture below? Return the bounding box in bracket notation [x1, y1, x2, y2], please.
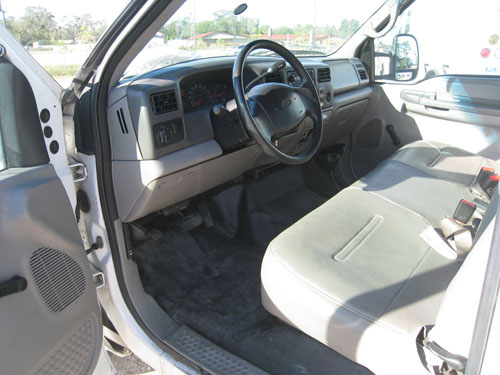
[75, 1, 500, 374]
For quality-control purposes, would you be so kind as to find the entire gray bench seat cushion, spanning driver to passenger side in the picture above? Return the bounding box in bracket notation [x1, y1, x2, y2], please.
[261, 142, 496, 374]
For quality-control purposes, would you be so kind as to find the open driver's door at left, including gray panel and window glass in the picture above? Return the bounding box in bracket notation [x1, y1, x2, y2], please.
[0, 47, 102, 375]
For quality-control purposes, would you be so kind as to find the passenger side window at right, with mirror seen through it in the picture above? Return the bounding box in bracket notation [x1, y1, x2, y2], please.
[375, 0, 500, 82]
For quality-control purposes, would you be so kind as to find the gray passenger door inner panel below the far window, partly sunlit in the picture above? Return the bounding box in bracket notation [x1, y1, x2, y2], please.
[351, 76, 500, 177]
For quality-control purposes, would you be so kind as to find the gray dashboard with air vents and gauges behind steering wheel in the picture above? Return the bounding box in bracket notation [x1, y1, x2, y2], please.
[108, 57, 371, 222]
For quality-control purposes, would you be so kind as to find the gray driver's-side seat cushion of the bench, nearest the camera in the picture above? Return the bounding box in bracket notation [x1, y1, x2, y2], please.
[261, 187, 460, 374]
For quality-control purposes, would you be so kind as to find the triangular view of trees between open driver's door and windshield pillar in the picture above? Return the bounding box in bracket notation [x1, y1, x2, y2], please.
[0, 0, 128, 87]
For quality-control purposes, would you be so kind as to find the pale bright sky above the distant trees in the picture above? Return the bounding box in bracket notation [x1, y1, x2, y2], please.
[0, 0, 384, 27]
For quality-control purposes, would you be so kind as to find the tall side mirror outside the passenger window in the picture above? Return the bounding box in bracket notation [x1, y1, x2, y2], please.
[394, 34, 418, 81]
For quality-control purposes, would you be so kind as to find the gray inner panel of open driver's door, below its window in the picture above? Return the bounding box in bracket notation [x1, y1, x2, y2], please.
[0, 164, 102, 374]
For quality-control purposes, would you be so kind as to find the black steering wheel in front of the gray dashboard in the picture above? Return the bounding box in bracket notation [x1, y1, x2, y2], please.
[233, 40, 323, 164]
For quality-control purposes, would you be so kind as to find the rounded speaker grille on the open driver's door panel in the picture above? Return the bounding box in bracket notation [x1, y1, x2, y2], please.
[30, 247, 86, 313]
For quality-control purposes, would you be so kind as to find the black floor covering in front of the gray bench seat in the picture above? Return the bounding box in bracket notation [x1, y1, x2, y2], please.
[134, 168, 370, 375]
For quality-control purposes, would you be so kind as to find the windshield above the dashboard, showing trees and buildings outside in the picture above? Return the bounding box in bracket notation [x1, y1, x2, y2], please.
[124, 0, 385, 77]
